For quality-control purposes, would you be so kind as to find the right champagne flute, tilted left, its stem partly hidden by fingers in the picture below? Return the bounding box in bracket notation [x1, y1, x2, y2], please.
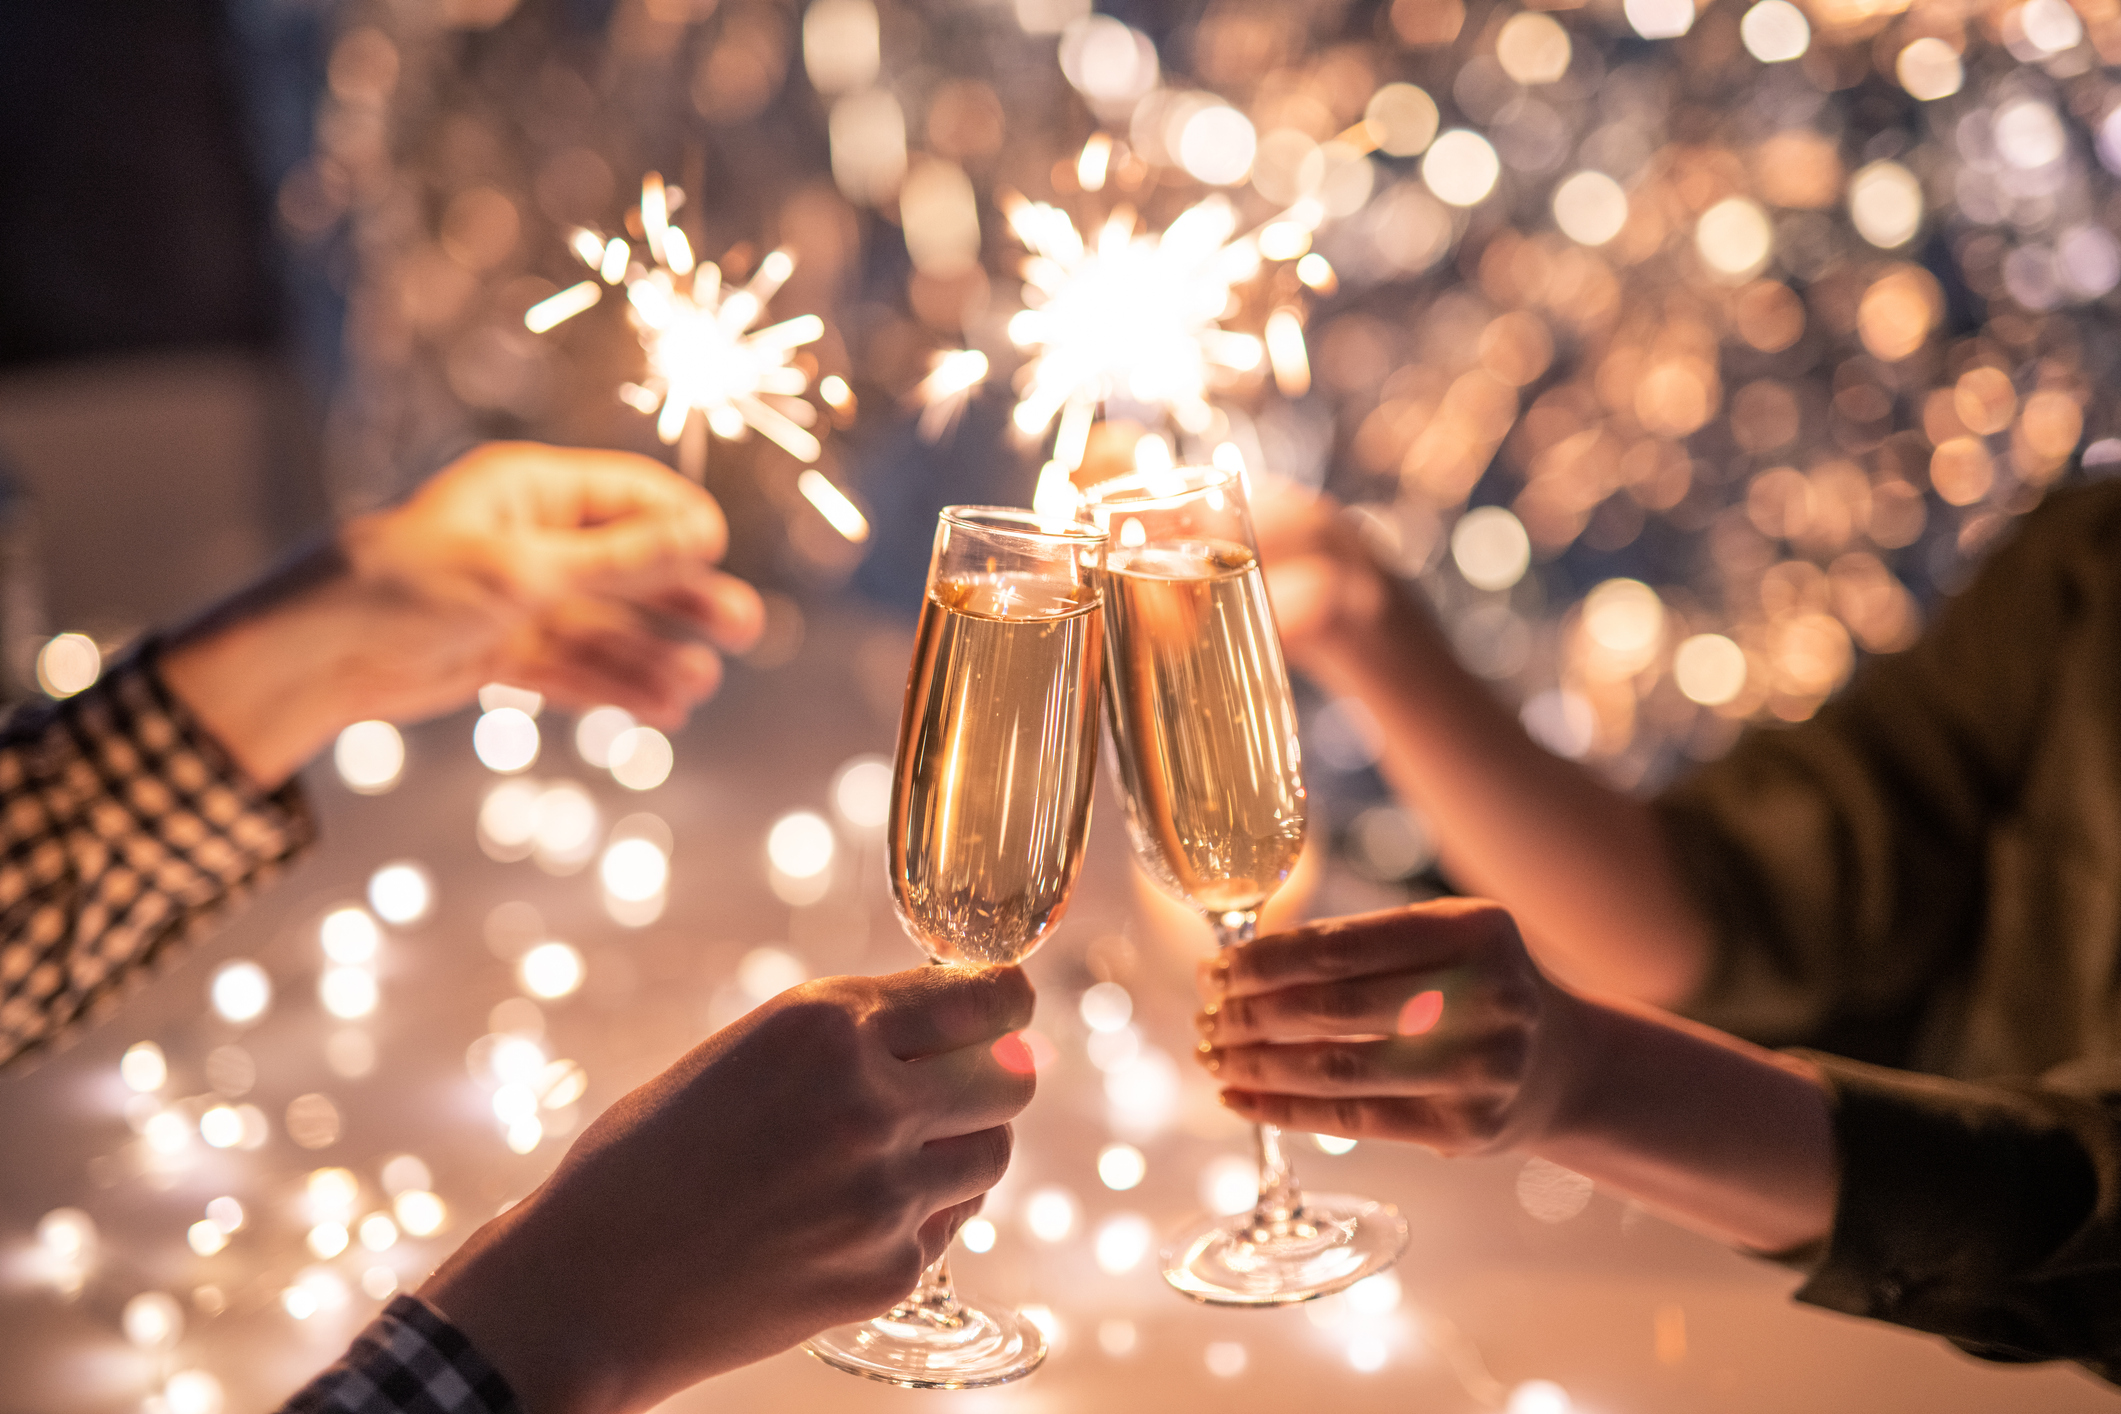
[1084, 466, 1406, 1306]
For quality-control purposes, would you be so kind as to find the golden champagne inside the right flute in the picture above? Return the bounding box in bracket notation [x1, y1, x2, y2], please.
[1105, 541, 1304, 914]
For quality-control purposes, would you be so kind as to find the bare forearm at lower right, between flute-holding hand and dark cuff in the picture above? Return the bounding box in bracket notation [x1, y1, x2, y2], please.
[1525, 998, 1839, 1253]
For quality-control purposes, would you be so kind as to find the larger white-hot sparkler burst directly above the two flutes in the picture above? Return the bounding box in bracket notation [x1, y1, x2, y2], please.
[1003, 140, 1317, 469]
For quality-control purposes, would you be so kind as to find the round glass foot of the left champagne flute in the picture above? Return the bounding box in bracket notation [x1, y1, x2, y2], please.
[804, 1300, 1046, 1389]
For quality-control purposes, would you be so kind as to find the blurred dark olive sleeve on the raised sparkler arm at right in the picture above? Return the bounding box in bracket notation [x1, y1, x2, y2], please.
[1654, 485, 2121, 1060]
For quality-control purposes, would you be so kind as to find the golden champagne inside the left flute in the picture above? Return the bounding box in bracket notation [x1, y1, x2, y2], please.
[891, 575, 1105, 965]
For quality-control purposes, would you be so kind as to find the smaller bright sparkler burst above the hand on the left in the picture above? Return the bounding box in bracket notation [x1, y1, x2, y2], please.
[524, 172, 827, 474]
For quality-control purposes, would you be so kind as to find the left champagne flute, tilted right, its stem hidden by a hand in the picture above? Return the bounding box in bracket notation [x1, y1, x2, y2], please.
[808, 507, 1105, 1389]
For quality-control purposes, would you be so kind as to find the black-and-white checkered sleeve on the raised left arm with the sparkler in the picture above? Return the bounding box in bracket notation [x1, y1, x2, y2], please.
[0, 640, 316, 1066]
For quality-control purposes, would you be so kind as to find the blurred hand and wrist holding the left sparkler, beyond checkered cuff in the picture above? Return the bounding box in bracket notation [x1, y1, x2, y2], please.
[161, 443, 761, 786]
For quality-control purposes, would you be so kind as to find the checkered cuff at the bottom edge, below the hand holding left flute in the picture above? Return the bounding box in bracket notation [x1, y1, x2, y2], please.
[280, 1295, 522, 1414]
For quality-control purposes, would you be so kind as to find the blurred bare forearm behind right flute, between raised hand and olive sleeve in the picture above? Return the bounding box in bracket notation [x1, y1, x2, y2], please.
[1304, 594, 1710, 1005]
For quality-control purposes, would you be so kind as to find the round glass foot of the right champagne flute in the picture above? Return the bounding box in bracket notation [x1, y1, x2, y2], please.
[1162, 1194, 1406, 1306]
